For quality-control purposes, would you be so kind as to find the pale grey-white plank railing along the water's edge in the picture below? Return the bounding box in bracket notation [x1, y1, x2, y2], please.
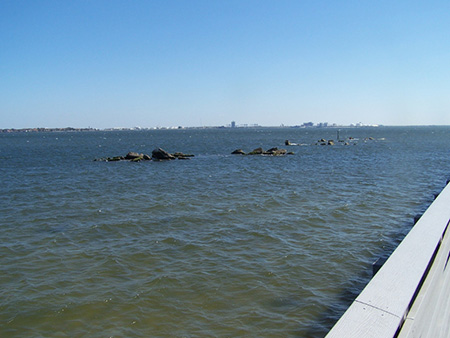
[326, 184, 450, 338]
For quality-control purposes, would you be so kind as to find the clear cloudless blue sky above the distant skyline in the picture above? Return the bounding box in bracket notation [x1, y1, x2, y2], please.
[0, 0, 450, 128]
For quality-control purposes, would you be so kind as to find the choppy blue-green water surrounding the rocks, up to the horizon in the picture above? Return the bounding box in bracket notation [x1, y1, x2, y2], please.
[0, 127, 450, 337]
